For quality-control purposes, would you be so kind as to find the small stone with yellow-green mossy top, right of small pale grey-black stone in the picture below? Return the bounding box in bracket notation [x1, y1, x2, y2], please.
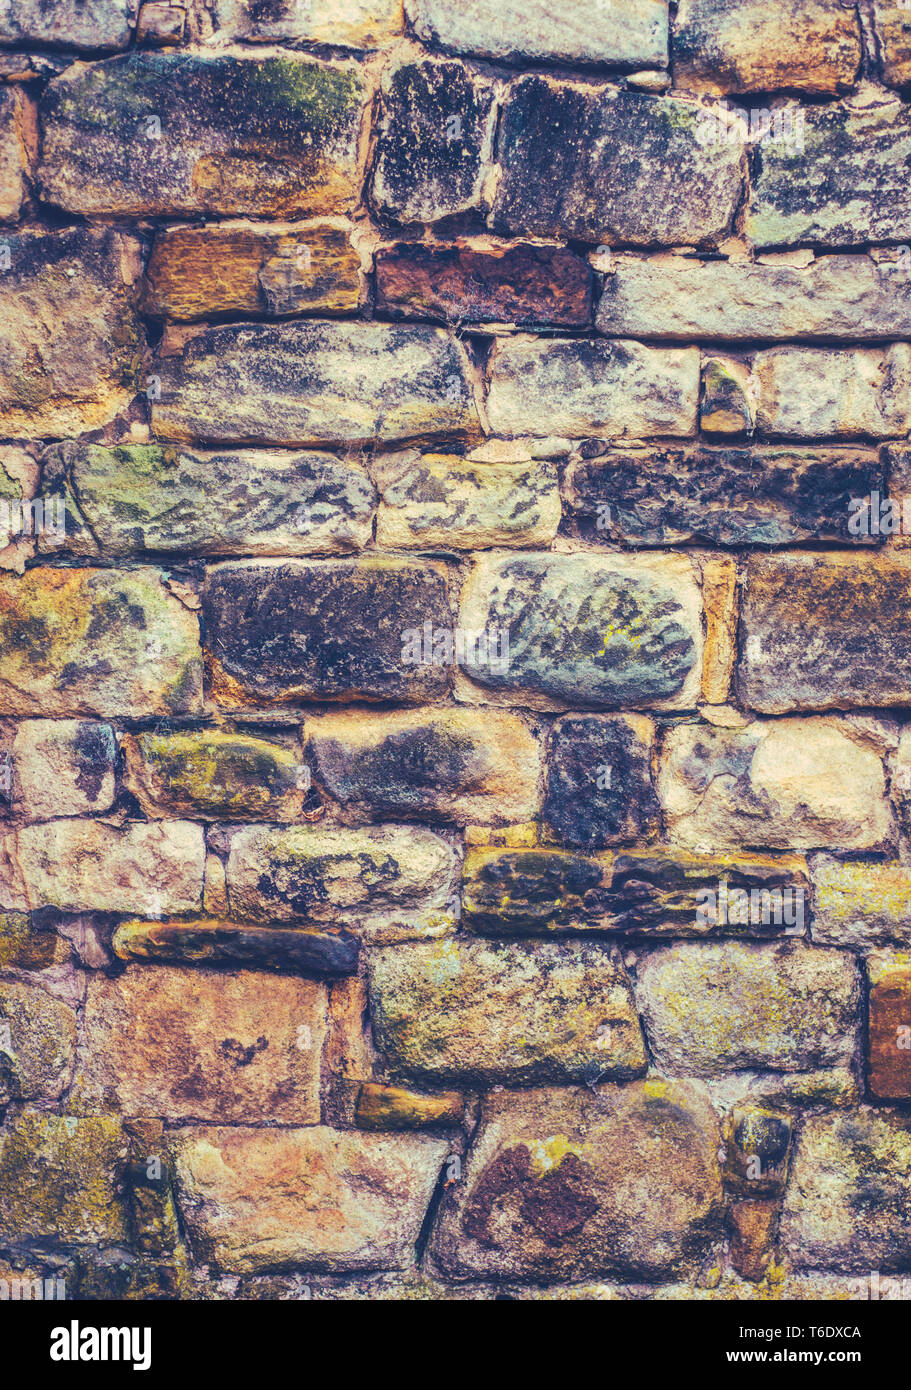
[122, 730, 306, 820]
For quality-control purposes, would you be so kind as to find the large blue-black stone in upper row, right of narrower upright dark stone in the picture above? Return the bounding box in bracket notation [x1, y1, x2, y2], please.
[492, 75, 743, 246]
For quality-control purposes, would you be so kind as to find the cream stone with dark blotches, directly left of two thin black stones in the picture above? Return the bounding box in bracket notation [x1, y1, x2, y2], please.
[227, 826, 455, 937]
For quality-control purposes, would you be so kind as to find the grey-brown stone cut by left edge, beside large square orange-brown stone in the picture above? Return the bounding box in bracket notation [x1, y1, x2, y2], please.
[0, 981, 76, 1105]
